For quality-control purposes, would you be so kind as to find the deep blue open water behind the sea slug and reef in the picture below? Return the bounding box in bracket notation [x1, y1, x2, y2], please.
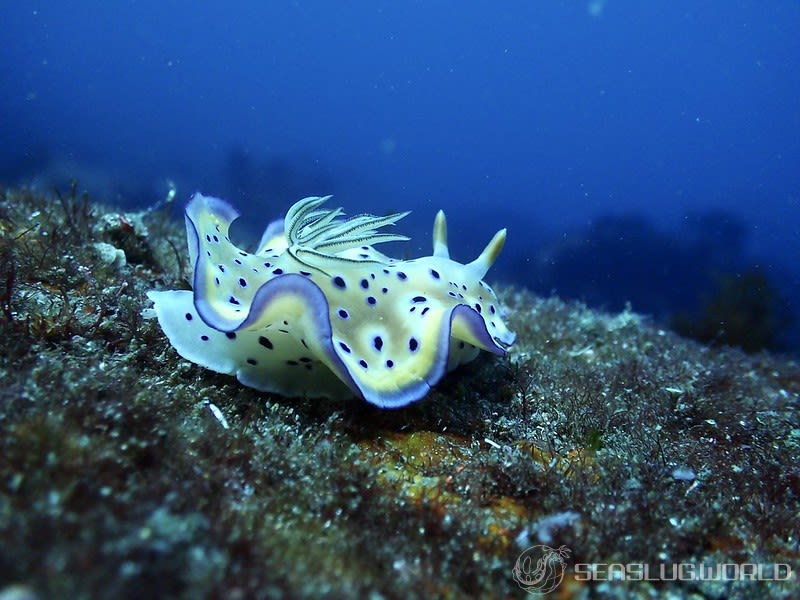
[0, 0, 800, 351]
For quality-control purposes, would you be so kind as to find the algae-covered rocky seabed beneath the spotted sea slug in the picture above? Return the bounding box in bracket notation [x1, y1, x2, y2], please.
[0, 188, 800, 598]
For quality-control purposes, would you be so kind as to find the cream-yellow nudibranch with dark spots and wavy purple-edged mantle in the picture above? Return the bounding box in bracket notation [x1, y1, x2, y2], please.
[148, 193, 515, 408]
